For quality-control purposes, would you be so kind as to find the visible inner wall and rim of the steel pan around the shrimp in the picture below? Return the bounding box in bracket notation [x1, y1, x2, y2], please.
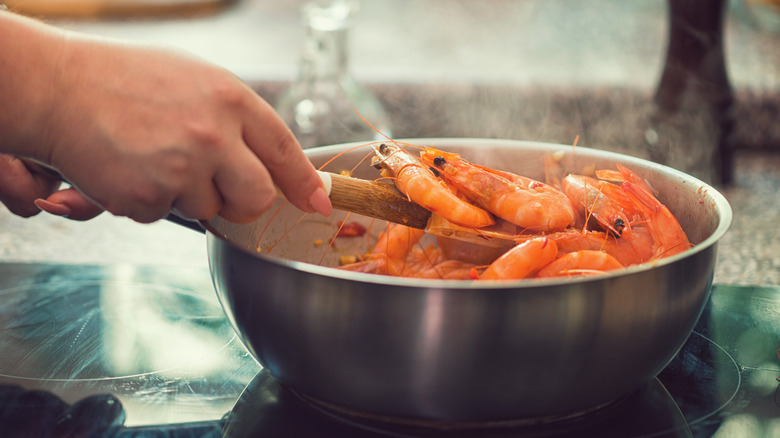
[209, 139, 731, 276]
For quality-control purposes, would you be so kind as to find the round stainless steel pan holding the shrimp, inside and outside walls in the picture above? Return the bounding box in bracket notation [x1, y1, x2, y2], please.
[201, 139, 731, 422]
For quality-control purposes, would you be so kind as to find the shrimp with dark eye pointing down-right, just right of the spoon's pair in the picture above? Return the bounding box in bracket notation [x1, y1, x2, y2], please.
[562, 174, 637, 236]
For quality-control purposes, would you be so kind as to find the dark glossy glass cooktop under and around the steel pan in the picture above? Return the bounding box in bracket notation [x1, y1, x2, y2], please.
[0, 264, 780, 438]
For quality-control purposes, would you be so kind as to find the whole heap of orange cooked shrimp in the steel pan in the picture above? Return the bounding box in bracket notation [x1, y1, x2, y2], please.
[330, 143, 690, 280]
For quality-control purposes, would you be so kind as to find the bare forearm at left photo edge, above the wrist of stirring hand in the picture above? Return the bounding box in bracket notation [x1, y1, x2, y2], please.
[0, 11, 66, 161]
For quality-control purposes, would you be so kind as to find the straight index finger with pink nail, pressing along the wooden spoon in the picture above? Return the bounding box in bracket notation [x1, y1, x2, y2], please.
[242, 92, 332, 216]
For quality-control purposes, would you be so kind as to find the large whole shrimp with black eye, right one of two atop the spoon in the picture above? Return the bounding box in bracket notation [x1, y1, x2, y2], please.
[421, 148, 575, 231]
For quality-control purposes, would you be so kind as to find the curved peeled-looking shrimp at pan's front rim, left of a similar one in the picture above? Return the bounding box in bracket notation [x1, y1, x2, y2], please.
[479, 237, 558, 280]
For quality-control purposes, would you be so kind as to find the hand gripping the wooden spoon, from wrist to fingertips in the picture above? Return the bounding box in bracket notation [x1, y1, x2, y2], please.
[4, 13, 331, 222]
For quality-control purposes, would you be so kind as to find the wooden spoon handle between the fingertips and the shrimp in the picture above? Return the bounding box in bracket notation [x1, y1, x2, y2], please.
[319, 172, 431, 230]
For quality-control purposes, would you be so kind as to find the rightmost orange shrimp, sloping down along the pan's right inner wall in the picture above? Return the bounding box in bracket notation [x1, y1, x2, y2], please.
[621, 181, 691, 259]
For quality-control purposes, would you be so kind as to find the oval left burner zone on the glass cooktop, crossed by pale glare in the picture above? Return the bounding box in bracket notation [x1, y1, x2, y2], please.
[0, 281, 234, 381]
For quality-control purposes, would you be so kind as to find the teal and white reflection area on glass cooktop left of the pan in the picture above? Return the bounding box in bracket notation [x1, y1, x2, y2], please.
[0, 266, 260, 428]
